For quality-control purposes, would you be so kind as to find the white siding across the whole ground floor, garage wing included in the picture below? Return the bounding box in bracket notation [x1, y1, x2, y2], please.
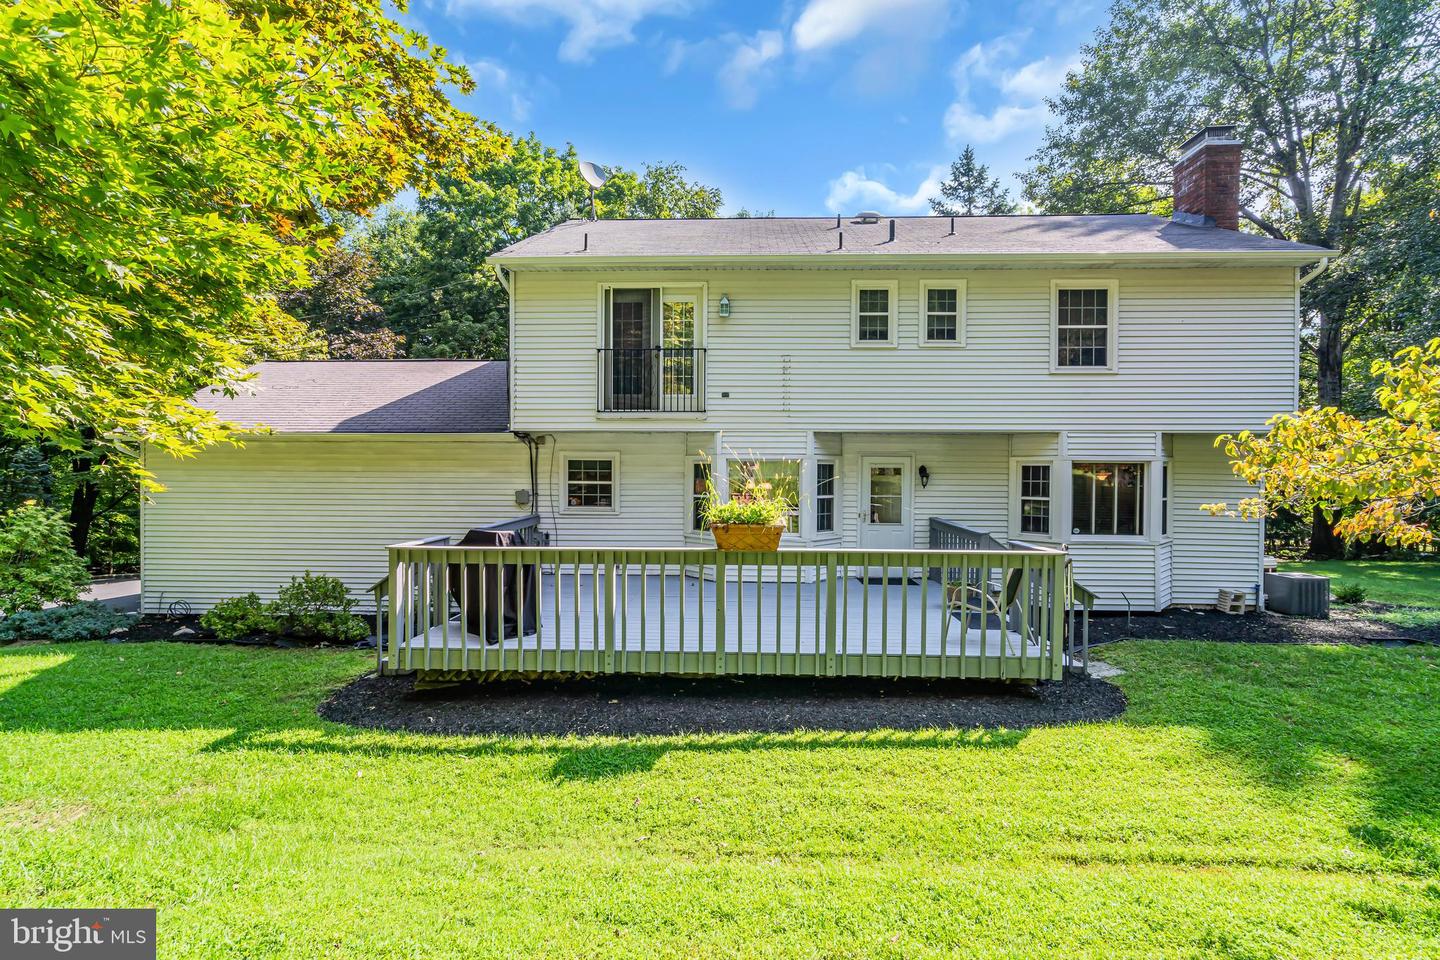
[141, 432, 1261, 612]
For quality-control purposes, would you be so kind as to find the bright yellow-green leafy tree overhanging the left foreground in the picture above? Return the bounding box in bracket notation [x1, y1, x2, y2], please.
[0, 0, 504, 471]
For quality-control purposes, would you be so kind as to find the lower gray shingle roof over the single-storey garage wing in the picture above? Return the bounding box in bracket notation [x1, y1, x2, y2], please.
[194, 360, 510, 433]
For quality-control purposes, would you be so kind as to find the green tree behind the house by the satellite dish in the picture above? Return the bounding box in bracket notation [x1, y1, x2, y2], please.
[353, 134, 721, 358]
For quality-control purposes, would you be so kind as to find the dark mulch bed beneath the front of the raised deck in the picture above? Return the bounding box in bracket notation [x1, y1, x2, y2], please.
[320, 675, 1125, 735]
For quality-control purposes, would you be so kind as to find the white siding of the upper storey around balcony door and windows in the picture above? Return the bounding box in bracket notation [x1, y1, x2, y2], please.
[511, 268, 1296, 431]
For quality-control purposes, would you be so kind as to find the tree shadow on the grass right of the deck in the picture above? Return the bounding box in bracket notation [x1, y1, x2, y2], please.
[1112, 642, 1440, 877]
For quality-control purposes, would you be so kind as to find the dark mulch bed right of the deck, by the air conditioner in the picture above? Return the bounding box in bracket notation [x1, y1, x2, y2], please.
[1090, 603, 1440, 645]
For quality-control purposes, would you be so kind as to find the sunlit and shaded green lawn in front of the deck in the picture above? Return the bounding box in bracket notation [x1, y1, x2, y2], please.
[0, 642, 1440, 960]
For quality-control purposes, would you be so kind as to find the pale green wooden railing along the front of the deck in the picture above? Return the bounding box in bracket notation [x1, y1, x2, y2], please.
[374, 538, 1084, 679]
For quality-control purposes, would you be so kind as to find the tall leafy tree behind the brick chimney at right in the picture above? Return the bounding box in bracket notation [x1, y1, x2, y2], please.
[1022, 0, 1440, 553]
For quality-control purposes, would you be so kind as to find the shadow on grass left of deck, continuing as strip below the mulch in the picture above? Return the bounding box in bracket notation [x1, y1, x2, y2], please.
[0, 643, 1025, 782]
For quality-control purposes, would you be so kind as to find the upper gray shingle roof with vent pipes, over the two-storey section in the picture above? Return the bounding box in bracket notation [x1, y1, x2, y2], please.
[491, 214, 1331, 262]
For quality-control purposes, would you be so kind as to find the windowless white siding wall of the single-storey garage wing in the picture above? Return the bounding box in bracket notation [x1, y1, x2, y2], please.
[141, 438, 530, 613]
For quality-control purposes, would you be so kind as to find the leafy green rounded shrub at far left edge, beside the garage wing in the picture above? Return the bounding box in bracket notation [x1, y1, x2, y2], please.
[0, 501, 89, 613]
